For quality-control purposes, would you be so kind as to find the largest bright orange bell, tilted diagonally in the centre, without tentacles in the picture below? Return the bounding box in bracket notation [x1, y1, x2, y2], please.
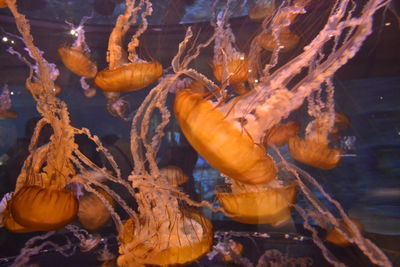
[174, 89, 277, 184]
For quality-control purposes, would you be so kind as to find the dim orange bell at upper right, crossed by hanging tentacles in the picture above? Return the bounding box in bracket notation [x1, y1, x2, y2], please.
[258, 27, 300, 52]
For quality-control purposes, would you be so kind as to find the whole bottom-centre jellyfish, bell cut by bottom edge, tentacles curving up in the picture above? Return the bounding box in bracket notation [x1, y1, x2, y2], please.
[117, 71, 213, 266]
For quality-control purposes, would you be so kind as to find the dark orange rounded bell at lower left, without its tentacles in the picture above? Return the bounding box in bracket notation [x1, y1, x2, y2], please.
[10, 185, 78, 231]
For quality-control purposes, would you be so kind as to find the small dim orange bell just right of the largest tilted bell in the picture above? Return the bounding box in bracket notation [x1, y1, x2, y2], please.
[263, 121, 300, 147]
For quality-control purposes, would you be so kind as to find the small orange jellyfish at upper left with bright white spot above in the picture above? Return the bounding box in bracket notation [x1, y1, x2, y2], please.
[57, 17, 97, 78]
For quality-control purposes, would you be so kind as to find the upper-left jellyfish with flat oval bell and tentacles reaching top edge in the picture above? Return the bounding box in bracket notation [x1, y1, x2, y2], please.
[94, 0, 163, 93]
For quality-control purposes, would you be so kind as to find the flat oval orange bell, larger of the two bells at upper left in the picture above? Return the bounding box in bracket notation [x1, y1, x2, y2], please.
[94, 61, 163, 92]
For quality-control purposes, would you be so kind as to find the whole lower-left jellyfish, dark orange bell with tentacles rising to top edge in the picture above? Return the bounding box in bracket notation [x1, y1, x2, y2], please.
[2, 0, 123, 232]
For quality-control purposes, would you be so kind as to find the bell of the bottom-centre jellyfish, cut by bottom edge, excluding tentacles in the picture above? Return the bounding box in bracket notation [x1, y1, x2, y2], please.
[117, 210, 213, 266]
